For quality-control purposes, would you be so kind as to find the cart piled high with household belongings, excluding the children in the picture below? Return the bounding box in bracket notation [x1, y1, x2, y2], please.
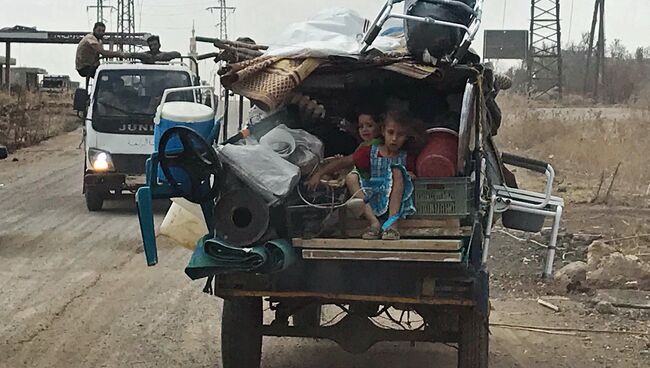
[137, 1, 564, 368]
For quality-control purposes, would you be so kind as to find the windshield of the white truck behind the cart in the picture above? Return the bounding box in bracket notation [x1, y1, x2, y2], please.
[93, 70, 194, 117]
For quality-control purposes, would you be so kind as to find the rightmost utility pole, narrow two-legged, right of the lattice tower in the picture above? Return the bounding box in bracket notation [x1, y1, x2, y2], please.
[583, 0, 605, 100]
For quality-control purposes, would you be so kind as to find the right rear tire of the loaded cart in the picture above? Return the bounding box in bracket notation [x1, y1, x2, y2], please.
[458, 308, 489, 368]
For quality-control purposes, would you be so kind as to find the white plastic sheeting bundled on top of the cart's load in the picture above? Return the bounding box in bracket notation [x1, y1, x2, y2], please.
[266, 8, 405, 57]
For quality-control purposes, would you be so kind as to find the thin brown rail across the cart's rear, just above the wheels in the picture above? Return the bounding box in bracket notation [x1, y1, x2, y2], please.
[214, 289, 474, 306]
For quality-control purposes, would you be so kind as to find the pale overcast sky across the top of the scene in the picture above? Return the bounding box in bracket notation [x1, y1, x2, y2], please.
[0, 0, 650, 79]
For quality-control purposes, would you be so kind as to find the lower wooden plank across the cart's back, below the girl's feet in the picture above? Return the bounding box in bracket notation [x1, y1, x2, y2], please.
[302, 249, 462, 263]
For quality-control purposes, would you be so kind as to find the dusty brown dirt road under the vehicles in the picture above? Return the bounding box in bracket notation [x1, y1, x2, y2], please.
[0, 131, 645, 368]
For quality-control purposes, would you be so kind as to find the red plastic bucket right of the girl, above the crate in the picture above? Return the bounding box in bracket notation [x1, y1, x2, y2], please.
[415, 128, 458, 178]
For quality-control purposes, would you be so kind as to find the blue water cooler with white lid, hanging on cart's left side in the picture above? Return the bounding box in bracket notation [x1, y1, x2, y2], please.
[153, 99, 218, 189]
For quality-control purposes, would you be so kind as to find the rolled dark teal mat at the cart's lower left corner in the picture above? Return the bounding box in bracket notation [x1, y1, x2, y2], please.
[185, 235, 296, 280]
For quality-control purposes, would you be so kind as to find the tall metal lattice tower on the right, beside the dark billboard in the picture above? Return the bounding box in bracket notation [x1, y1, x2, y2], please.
[528, 0, 563, 99]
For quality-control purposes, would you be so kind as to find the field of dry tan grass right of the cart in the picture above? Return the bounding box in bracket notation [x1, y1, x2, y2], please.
[497, 99, 650, 200]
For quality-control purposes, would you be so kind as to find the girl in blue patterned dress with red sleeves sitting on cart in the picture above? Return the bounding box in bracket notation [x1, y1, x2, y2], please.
[307, 110, 419, 240]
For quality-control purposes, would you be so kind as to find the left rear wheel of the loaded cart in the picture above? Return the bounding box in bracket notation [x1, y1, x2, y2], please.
[221, 297, 262, 368]
